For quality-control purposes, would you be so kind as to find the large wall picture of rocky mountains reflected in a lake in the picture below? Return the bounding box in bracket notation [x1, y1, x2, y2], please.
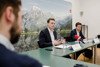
[14, 0, 72, 52]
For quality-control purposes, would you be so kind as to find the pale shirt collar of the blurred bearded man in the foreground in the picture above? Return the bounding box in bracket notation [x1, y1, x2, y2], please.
[0, 34, 15, 51]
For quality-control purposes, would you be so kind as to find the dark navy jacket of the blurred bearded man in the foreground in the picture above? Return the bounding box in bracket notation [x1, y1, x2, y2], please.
[0, 44, 42, 67]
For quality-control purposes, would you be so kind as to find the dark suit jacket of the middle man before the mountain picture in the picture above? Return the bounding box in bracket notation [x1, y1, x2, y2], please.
[38, 28, 57, 48]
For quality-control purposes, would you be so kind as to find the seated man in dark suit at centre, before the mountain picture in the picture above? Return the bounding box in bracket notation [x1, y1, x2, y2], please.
[39, 18, 64, 48]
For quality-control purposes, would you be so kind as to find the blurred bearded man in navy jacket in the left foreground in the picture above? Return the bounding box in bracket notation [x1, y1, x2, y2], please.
[0, 0, 42, 67]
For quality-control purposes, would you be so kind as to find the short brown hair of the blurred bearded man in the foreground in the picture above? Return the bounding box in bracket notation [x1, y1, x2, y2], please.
[0, 0, 21, 19]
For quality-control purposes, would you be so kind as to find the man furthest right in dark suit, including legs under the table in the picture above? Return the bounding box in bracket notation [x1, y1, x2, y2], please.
[70, 22, 92, 59]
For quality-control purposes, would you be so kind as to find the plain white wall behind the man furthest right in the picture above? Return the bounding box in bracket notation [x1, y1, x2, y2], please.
[72, 0, 100, 38]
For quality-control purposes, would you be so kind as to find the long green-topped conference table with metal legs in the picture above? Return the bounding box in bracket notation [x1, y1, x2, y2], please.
[22, 42, 100, 67]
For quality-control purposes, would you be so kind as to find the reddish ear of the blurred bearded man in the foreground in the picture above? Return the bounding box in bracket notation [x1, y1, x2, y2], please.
[5, 7, 14, 23]
